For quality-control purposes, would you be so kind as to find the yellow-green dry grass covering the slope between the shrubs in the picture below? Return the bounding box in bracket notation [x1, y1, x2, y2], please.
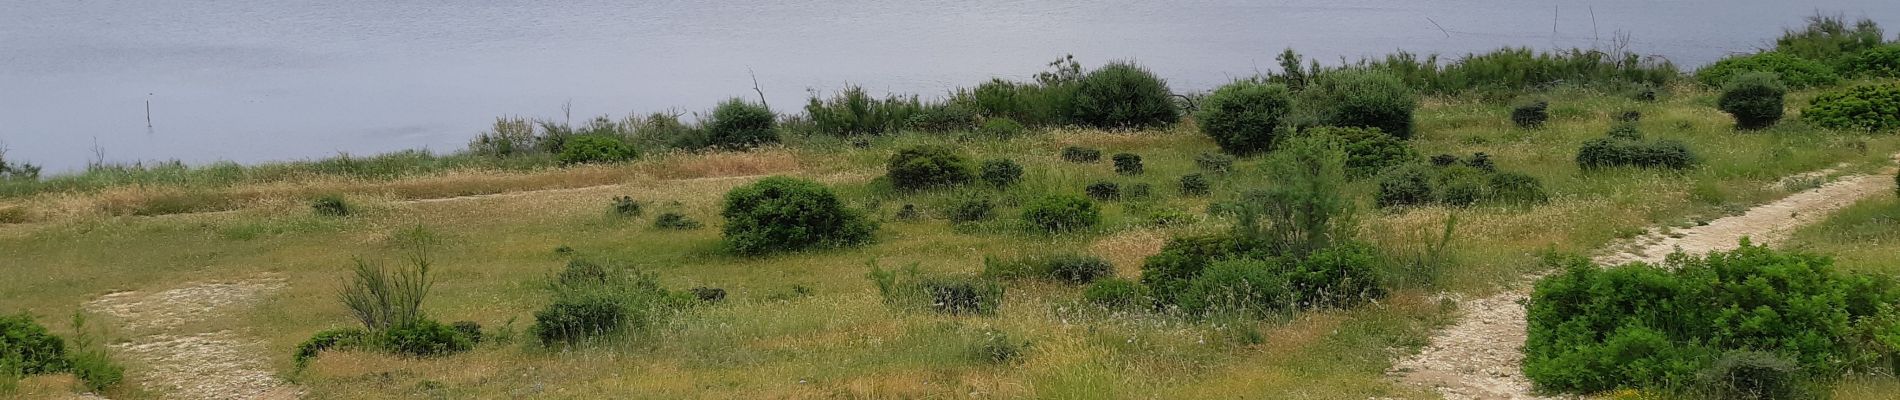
[0, 79, 1900, 398]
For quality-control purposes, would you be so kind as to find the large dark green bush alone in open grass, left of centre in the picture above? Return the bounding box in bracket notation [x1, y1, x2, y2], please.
[720, 176, 878, 254]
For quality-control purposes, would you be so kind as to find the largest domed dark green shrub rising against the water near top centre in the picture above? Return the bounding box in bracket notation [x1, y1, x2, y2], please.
[1075, 63, 1180, 129]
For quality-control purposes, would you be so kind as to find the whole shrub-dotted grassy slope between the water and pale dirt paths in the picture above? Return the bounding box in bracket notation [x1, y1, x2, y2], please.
[0, 17, 1900, 398]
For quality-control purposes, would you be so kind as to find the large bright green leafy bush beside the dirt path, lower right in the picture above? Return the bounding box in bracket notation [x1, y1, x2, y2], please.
[1524, 241, 1900, 398]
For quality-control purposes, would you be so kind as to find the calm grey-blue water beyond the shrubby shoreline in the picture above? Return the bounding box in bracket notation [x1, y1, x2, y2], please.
[0, 0, 1900, 171]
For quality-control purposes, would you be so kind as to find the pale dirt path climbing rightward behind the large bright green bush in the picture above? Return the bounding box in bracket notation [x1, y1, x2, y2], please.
[1391, 161, 1892, 400]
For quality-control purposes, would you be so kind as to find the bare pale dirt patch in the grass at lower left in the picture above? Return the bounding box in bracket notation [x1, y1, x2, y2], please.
[86, 275, 298, 400]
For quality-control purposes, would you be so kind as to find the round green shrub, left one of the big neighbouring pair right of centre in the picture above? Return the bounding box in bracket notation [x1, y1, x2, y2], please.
[1195, 82, 1294, 155]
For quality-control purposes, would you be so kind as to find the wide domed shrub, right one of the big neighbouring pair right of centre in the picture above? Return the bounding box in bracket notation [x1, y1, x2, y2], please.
[1296, 70, 1419, 138]
